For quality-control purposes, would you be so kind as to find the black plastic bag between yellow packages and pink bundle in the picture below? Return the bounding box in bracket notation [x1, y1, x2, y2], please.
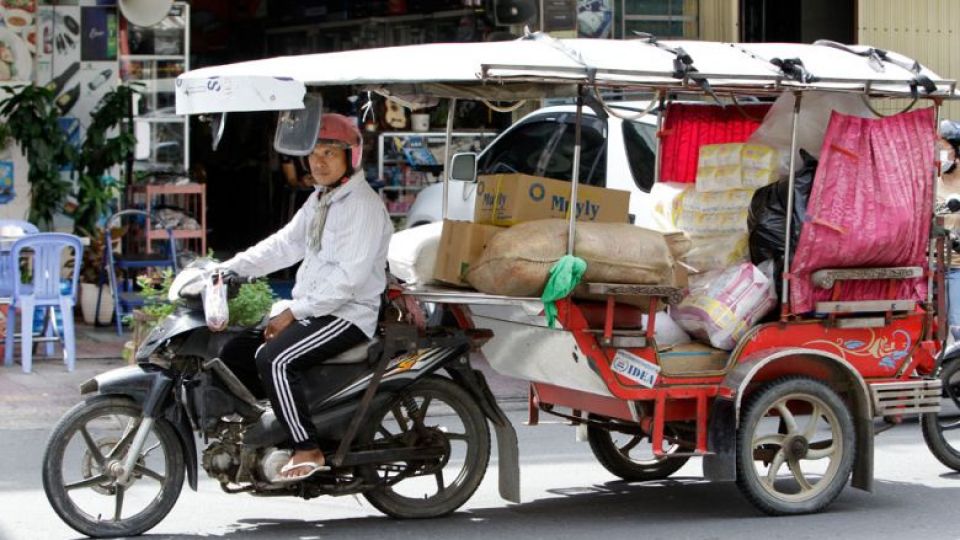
[747, 149, 817, 298]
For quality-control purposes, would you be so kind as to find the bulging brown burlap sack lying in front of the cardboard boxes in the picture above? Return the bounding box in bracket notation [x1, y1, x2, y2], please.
[467, 219, 686, 296]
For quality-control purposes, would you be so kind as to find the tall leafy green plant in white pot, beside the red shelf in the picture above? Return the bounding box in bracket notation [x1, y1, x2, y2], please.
[73, 85, 137, 324]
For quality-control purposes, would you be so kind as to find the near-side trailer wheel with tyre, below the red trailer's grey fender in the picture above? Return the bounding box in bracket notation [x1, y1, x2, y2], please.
[737, 377, 856, 515]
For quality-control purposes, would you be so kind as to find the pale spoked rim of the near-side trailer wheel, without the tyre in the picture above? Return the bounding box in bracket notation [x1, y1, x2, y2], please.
[751, 393, 846, 503]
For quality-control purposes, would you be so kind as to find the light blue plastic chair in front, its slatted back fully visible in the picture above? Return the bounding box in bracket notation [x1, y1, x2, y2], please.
[4, 233, 83, 373]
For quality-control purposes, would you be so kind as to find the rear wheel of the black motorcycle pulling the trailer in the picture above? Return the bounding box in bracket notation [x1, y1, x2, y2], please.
[358, 377, 490, 518]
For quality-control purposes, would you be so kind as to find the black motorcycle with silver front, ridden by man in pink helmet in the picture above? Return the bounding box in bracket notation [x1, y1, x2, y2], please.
[43, 260, 518, 537]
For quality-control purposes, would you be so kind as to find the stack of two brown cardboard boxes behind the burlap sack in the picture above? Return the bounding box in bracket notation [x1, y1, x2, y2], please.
[433, 174, 630, 287]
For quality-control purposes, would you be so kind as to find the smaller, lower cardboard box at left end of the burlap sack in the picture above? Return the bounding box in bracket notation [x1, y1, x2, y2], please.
[433, 221, 504, 287]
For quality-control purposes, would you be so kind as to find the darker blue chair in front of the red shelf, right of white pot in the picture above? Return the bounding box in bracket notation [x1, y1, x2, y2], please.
[102, 210, 177, 335]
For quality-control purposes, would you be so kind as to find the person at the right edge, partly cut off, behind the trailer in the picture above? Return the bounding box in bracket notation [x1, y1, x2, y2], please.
[937, 120, 960, 341]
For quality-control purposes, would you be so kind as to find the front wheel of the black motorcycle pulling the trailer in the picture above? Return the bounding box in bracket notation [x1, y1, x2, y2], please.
[43, 397, 184, 537]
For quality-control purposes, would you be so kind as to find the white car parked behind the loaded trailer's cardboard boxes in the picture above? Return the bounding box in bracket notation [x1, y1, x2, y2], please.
[407, 101, 659, 228]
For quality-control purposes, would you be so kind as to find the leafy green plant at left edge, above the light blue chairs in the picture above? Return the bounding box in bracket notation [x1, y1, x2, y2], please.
[0, 84, 75, 230]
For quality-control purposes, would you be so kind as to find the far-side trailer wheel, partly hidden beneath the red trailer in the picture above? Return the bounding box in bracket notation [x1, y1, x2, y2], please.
[587, 417, 690, 482]
